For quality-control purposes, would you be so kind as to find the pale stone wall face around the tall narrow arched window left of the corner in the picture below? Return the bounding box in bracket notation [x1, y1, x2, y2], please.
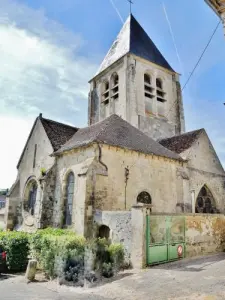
[53, 146, 95, 235]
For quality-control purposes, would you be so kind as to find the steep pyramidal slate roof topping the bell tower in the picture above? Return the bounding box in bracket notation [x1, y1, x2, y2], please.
[96, 15, 174, 75]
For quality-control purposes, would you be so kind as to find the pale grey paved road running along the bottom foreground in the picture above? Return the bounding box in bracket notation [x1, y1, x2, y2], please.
[0, 253, 225, 300]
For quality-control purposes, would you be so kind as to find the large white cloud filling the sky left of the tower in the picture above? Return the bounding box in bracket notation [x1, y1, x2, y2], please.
[0, 0, 97, 188]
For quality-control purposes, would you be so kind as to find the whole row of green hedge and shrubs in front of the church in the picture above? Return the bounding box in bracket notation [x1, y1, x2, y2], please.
[0, 228, 124, 283]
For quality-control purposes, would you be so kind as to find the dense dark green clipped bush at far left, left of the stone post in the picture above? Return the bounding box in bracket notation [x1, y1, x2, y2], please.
[0, 231, 29, 272]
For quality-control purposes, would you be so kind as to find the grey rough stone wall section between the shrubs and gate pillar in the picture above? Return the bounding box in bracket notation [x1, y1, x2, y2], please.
[94, 210, 132, 263]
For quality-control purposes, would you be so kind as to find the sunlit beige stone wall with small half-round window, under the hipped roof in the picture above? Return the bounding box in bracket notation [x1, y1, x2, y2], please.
[96, 145, 185, 213]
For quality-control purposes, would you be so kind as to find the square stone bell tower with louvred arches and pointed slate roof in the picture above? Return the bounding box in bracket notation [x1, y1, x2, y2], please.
[88, 14, 185, 139]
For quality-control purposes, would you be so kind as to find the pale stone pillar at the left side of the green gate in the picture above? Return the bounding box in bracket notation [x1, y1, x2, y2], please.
[131, 205, 147, 269]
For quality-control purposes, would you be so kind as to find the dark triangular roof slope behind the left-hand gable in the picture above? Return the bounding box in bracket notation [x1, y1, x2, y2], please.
[41, 118, 78, 151]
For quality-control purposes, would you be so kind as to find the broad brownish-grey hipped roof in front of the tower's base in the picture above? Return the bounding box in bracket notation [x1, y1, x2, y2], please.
[55, 115, 182, 160]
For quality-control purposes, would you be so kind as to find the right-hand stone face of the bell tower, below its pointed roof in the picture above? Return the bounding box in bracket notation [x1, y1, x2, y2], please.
[130, 56, 184, 140]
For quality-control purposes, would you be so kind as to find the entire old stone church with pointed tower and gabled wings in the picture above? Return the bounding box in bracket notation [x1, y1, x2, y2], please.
[6, 15, 225, 237]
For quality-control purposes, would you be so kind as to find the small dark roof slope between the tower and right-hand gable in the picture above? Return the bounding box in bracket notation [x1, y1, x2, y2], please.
[159, 129, 205, 154]
